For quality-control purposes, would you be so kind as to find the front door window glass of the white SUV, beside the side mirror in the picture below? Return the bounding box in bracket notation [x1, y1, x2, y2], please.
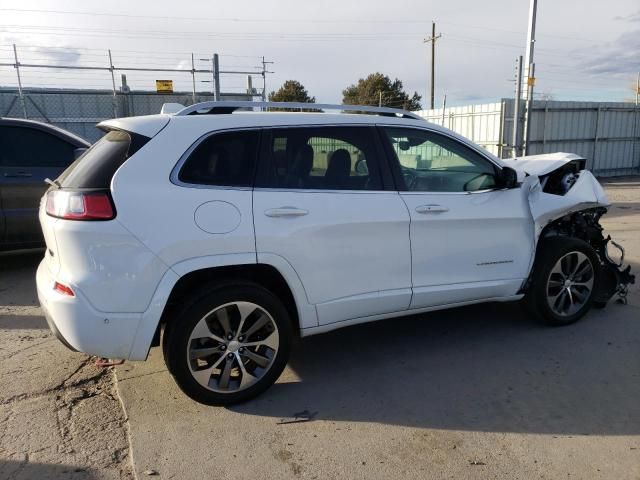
[384, 127, 497, 192]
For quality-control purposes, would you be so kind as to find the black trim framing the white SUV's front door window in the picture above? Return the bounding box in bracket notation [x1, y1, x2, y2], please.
[376, 123, 504, 195]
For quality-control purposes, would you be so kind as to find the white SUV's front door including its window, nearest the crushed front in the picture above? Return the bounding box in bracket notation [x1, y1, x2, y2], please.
[381, 127, 534, 308]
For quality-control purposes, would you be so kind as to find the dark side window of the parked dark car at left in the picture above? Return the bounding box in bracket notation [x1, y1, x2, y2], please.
[0, 126, 76, 169]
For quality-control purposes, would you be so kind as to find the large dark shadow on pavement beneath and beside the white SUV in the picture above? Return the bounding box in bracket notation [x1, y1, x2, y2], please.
[232, 296, 640, 435]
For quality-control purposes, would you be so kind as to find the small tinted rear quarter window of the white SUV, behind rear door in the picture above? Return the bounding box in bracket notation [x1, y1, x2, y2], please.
[178, 130, 259, 187]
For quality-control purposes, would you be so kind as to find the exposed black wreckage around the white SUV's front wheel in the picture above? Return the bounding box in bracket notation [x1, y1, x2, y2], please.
[540, 206, 635, 304]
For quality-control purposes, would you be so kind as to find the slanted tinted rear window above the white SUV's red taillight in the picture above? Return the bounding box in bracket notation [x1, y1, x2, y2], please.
[58, 130, 151, 189]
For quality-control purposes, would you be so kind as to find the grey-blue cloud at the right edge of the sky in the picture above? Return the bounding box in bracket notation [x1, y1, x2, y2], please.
[577, 29, 640, 75]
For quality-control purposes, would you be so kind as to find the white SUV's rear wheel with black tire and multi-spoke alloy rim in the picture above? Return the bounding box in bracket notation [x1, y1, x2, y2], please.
[163, 284, 292, 405]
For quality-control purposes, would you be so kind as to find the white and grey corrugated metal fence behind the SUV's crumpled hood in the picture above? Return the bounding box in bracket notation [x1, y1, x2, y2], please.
[418, 99, 640, 177]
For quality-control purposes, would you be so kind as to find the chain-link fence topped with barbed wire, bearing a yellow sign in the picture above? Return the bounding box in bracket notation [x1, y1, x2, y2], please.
[0, 45, 272, 142]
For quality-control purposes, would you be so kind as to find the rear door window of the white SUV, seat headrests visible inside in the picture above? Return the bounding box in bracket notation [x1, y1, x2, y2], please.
[259, 127, 382, 190]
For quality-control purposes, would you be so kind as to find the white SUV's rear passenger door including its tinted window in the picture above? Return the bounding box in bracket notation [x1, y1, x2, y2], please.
[254, 126, 411, 324]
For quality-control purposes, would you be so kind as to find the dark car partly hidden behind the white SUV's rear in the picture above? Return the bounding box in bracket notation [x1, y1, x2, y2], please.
[0, 118, 91, 251]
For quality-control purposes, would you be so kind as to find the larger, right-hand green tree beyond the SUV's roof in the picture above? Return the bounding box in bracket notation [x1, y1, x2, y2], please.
[342, 72, 422, 110]
